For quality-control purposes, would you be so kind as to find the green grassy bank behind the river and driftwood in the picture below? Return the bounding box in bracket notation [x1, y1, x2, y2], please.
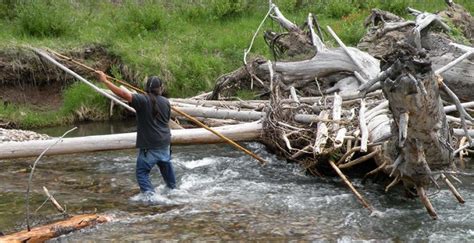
[0, 0, 474, 126]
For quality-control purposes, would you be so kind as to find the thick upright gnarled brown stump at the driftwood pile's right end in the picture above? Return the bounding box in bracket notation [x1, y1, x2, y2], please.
[382, 46, 454, 188]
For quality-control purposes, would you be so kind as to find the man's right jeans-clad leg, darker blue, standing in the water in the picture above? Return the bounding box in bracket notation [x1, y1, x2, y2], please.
[150, 146, 176, 189]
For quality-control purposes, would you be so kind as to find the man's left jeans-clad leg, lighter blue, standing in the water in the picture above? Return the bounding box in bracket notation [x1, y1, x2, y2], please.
[136, 149, 156, 193]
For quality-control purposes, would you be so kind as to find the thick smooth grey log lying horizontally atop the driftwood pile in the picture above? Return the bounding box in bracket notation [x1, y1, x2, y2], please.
[209, 48, 380, 99]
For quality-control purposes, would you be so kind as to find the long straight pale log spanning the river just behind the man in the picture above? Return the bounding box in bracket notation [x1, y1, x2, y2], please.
[0, 123, 262, 159]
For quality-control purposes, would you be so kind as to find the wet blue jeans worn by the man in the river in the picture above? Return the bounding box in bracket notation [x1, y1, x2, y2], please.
[136, 145, 176, 192]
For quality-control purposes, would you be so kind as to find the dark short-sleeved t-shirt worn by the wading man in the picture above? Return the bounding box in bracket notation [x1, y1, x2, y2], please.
[130, 94, 171, 149]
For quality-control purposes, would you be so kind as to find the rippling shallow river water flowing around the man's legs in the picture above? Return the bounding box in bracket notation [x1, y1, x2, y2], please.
[0, 123, 474, 242]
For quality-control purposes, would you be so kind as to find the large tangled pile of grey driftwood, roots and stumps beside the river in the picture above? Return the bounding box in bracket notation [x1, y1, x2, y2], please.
[169, 3, 474, 219]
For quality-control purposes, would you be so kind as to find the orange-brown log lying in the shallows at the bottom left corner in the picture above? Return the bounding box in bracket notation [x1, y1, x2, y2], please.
[0, 214, 110, 242]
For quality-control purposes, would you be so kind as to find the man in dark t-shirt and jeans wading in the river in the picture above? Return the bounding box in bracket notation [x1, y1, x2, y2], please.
[96, 71, 176, 195]
